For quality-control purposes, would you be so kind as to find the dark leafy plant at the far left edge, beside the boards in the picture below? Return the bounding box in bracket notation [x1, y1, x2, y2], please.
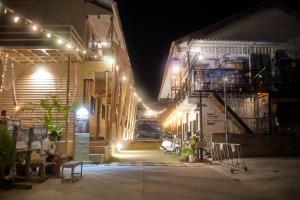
[0, 124, 15, 189]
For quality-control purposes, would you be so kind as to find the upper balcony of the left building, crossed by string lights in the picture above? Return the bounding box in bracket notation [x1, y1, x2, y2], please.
[0, 25, 85, 64]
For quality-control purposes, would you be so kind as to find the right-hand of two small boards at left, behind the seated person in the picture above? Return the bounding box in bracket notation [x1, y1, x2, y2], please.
[31, 125, 48, 149]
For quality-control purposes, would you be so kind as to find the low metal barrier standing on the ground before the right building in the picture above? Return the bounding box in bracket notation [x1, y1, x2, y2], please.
[211, 142, 248, 173]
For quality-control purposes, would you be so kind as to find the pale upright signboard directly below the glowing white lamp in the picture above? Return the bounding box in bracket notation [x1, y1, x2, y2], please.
[74, 133, 90, 161]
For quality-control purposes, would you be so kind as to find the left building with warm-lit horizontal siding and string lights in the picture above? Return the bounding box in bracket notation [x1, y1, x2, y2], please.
[0, 0, 138, 159]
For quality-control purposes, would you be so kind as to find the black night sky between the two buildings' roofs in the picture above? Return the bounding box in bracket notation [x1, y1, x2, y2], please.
[116, 0, 290, 103]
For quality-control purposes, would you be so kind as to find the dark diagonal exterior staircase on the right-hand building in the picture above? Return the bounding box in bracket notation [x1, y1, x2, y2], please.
[209, 92, 254, 134]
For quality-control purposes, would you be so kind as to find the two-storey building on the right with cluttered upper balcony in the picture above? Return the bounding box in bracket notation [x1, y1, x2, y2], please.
[158, 4, 300, 142]
